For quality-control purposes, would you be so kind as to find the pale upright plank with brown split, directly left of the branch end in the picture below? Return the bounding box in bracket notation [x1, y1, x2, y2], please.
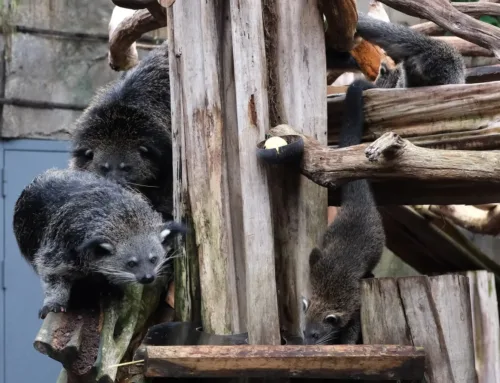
[230, 0, 282, 345]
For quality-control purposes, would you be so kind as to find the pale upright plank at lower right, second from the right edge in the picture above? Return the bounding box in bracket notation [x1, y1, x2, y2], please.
[429, 274, 477, 383]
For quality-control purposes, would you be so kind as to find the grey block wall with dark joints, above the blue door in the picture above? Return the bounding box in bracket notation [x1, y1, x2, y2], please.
[0, 0, 164, 139]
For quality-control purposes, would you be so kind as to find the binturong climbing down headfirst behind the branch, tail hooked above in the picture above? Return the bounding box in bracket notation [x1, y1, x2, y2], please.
[303, 80, 385, 344]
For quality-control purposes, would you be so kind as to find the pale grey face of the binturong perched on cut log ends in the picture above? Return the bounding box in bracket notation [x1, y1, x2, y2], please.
[80, 222, 185, 285]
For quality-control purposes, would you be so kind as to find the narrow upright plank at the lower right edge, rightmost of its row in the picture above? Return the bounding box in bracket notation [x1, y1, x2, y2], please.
[466, 270, 500, 383]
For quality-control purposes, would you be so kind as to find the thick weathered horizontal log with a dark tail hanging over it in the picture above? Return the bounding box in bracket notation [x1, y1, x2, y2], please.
[326, 81, 500, 149]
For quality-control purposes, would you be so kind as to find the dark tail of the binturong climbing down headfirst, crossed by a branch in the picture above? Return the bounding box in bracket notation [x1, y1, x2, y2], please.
[339, 80, 378, 208]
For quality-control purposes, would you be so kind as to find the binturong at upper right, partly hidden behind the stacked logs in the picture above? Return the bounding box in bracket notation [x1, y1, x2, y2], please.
[356, 14, 465, 88]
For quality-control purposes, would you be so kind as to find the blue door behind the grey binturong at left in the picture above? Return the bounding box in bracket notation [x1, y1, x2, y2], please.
[0, 140, 69, 383]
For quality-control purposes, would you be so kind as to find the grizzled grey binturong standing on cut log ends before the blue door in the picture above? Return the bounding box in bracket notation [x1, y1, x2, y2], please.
[14, 169, 184, 318]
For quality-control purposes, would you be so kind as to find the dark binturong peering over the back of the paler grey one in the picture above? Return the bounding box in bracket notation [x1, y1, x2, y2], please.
[70, 43, 173, 220]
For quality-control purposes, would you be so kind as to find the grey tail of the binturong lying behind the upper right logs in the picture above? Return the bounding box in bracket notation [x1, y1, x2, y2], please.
[357, 14, 443, 61]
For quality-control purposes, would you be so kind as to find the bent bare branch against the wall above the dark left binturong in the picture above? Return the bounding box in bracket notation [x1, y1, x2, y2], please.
[108, 7, 167, 71]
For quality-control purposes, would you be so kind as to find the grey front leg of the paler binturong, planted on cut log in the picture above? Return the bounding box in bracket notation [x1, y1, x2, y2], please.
[38, 275, 71, 319]
